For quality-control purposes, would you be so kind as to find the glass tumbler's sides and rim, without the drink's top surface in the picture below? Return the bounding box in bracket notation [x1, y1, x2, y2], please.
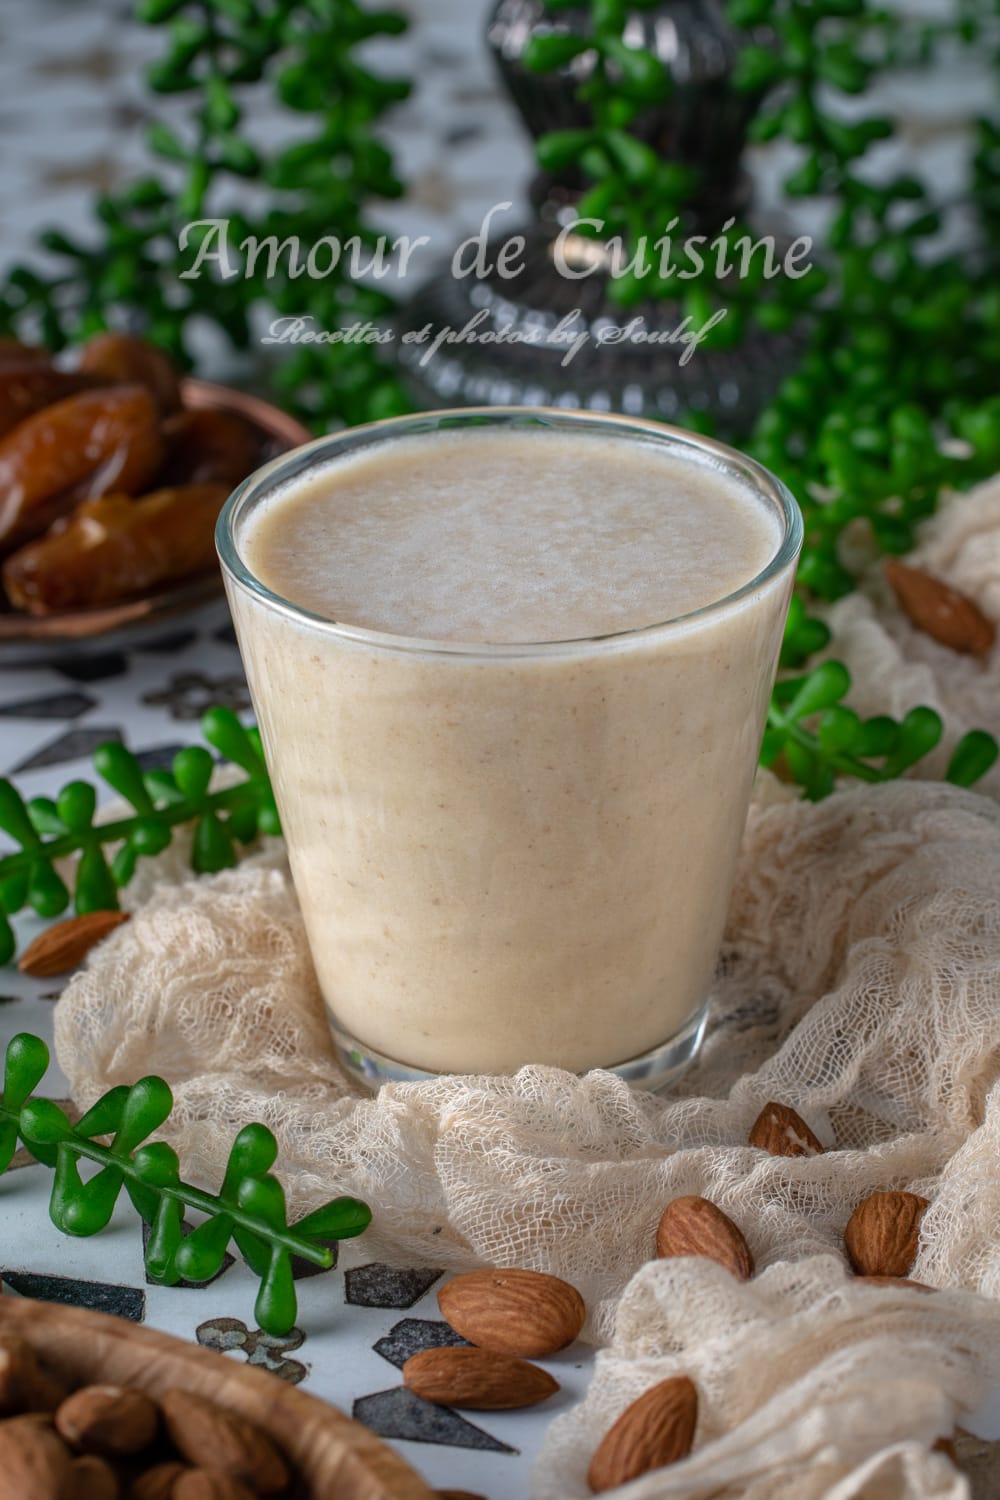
[217, 408, 802, 1088]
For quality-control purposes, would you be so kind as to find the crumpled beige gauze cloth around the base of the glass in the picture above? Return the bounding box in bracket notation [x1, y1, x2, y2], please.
[55, 477, 1000, 1500]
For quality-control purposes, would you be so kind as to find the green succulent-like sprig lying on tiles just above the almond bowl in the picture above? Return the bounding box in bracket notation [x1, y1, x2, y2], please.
[0, 1032, 372, 1335]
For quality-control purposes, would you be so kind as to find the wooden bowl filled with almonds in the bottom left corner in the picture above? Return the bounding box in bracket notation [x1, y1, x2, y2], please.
[0, 1298, 433, 1500]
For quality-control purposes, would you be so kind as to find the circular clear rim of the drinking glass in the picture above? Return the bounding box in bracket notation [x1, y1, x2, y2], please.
[216, 407, 802, 660]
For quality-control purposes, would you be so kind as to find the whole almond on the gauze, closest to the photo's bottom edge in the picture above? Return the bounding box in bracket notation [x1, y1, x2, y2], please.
[586, 1376, 699, 1494]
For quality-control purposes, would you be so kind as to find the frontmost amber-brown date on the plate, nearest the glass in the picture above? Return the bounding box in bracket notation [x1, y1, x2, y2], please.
[3, 485, 228, 615]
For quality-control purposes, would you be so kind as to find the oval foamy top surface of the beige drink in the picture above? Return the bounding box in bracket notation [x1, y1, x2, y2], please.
[243, 429, 780, 645]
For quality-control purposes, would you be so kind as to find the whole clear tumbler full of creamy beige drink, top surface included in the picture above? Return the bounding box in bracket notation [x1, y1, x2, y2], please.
[220, 413, 798, 1076]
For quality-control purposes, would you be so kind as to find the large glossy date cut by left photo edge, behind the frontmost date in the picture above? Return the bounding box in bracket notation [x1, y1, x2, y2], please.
[0, 386, 163, 552]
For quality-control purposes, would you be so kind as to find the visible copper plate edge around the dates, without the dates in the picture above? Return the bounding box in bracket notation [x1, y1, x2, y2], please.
[0, 378, 312, 666]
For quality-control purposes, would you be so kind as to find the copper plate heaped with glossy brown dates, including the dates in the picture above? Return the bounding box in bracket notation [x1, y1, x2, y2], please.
[0, 333, 310, 660]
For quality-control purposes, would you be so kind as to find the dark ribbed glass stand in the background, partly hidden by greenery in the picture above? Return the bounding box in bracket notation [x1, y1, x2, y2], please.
[394, 0, 796, 434]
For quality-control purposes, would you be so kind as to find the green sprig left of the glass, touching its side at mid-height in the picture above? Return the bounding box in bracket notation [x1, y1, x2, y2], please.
[0, 708, 280, 963]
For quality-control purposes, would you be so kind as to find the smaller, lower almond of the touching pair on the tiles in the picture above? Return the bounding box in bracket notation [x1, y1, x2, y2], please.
[403, 1347, 559, 1412]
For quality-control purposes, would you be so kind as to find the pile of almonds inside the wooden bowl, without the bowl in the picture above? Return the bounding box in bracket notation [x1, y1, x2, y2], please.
[0, 1335, 294, 1500]
